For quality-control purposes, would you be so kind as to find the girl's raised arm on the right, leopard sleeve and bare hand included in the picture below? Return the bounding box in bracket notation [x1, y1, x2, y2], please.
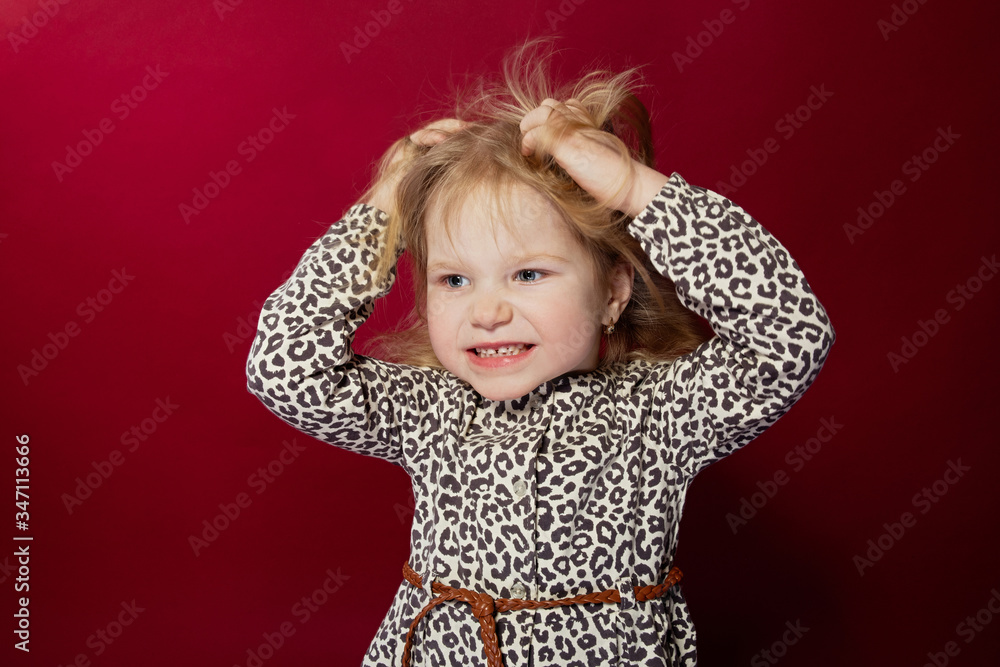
[521, 98, 835, 476]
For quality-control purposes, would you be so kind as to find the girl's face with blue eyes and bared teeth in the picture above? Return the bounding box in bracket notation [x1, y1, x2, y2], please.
[426, 186, 627, 400]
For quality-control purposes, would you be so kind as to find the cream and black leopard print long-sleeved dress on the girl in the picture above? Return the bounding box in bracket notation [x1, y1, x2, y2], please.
[247, 173, 835, 667]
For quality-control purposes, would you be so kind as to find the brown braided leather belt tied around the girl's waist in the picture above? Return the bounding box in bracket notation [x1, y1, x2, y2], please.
[403, 563, 683, 667]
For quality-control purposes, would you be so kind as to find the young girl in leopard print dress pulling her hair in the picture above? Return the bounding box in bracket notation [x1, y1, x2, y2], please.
[247, 43, 834, 667]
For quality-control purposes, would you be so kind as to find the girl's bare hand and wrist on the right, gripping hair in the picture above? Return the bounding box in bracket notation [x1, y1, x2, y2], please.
[521, 98, 668, 217]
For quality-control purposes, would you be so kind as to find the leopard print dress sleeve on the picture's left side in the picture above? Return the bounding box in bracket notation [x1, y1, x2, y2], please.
[246, 204, 437, 474]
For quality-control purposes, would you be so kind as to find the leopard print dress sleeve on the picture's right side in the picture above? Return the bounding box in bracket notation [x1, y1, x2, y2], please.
[629, 173, 835, 476]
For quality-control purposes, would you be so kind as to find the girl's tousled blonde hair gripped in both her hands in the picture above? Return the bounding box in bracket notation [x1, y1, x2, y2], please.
[360, 38, 709, 368]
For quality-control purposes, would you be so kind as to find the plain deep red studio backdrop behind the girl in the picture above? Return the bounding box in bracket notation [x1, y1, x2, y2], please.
[0, 0, 1000, 667]
